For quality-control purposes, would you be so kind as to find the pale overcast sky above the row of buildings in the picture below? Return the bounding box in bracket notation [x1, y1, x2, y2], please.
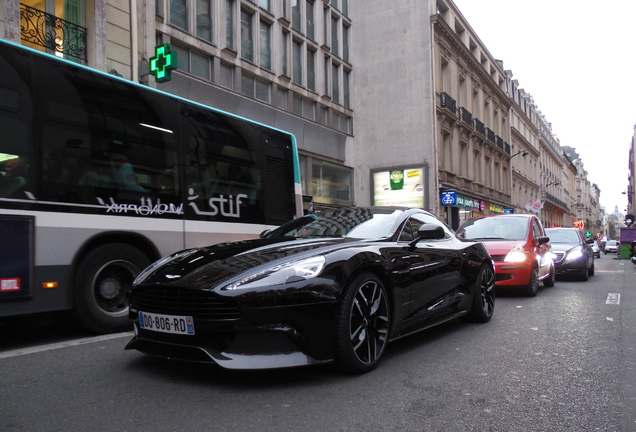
[454, 0, 636, 214]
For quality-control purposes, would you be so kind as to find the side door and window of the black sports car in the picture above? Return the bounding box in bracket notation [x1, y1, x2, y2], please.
[399, 214, 463, 330]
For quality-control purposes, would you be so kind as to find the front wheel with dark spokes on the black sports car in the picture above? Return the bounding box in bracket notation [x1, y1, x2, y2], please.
[334, 273, 391, 374]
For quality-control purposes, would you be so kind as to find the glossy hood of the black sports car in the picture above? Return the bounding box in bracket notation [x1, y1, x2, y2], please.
[135, 238, 363, 289]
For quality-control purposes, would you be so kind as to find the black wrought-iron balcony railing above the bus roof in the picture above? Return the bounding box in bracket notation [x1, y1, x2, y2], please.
[20, 4, 88, 63]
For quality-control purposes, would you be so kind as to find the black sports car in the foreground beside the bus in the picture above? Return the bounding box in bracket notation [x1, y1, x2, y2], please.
[126, 208, 495, 373]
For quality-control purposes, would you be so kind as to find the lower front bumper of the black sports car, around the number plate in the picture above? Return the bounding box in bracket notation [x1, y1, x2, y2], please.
[125, 302, 336, 369]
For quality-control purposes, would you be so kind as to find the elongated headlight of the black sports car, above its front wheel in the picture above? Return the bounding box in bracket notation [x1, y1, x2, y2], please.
[225, 256, 326, 290]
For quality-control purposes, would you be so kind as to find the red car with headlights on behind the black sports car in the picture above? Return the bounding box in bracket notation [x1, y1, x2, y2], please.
[457, 214, 556, 297]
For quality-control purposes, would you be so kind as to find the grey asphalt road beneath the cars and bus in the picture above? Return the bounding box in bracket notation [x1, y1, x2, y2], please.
[0, 255, 636, 432]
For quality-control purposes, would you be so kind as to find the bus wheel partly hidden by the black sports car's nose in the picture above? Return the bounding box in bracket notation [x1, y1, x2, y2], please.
[73, 243, 150, 333]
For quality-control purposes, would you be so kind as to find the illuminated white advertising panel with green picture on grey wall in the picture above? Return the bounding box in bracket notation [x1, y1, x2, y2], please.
[371, 167, 425, 208]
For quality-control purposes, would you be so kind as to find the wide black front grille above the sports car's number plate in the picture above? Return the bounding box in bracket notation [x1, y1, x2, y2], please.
[129, 285, 241, 320]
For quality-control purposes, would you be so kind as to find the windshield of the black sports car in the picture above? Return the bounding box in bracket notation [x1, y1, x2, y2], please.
[265, 208, 403, 238]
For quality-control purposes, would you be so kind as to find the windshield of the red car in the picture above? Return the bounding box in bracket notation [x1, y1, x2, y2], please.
[457, 216, 529, 241]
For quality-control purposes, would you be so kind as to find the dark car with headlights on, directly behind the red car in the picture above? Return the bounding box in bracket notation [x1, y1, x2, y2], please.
[545, 228, 594, 280]
